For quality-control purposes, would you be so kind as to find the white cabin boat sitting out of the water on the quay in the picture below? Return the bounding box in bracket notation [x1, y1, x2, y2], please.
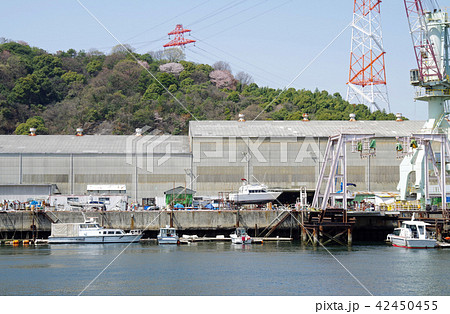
[230, 180, 281, 204]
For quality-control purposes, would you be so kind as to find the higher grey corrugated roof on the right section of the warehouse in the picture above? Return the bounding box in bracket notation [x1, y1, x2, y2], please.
[189, 120, 425, 137]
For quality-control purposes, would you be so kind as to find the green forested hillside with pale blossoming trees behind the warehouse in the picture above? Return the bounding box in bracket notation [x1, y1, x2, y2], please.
[0, 41, 395, 134]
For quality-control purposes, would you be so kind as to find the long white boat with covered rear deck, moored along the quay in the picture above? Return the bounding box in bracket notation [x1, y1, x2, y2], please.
[48, 218, 142, 244]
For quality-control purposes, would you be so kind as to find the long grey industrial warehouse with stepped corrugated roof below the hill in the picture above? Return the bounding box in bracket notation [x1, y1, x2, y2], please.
[0, 119, 424, 207]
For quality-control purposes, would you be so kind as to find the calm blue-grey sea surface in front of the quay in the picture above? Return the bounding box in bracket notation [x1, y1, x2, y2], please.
[0, 242, 450, 296]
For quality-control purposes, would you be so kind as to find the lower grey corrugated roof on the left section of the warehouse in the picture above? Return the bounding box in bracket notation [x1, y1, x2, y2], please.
[0, 135, 189, 154]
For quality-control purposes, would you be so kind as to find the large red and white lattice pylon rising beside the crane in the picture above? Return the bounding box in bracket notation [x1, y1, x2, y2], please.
[347, 0, 391, 112]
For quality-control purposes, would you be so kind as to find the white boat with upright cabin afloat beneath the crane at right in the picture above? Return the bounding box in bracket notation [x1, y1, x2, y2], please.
[386, 214, 437, 249]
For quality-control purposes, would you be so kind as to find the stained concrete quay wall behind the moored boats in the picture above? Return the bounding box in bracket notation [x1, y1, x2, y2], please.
[0, 210, 295, 233]
